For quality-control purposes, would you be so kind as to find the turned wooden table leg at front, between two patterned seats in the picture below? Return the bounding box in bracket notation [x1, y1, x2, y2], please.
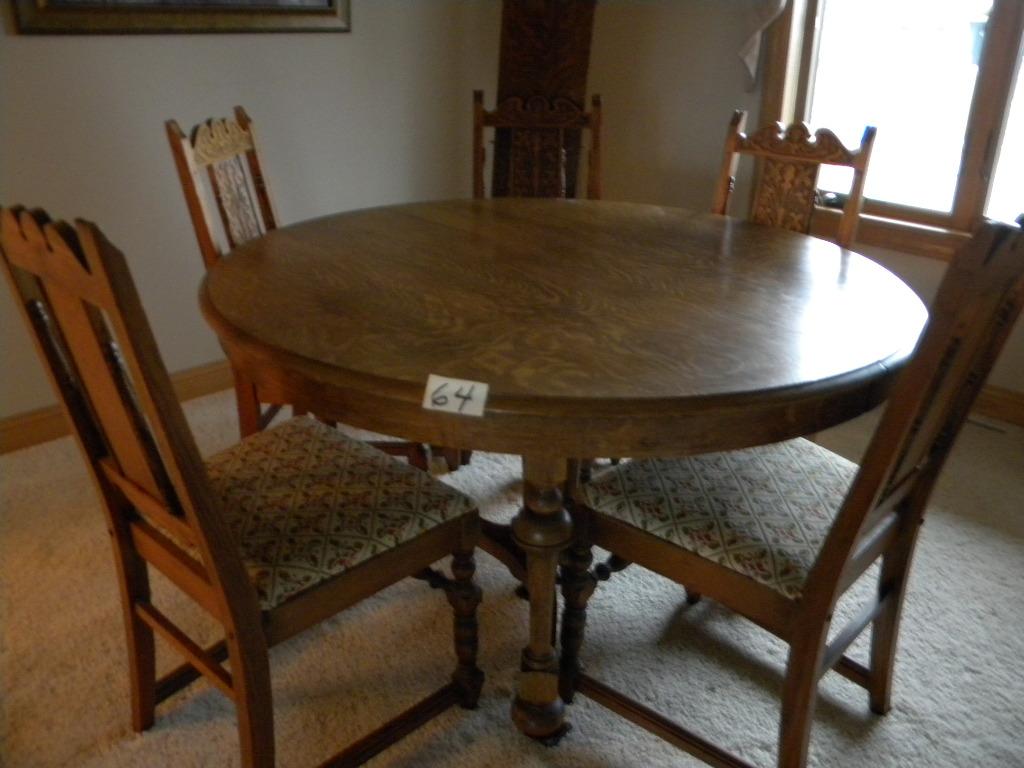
[512, 455, 572, 740]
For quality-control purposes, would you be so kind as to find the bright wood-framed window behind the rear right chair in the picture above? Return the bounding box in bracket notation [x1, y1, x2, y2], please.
[762, 0, 1024, 256]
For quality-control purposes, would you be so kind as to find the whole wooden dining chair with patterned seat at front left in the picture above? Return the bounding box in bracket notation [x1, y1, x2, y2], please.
[0, 208, 482, 766]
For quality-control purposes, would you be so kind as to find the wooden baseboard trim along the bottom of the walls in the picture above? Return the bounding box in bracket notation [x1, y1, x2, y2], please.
[0, 368, 1024, 454]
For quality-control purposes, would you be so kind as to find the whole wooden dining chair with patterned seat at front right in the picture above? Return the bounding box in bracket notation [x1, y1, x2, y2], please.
[561, 218, 1024, 768]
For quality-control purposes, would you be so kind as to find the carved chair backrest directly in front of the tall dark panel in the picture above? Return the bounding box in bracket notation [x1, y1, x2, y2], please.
[473, 91, 601, 200]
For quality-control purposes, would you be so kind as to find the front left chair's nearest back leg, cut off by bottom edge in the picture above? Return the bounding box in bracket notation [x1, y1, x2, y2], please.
[227, 635, 274, 768]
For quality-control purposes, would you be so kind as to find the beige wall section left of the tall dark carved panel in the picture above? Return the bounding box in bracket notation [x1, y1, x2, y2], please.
[0, 0, 500, 417]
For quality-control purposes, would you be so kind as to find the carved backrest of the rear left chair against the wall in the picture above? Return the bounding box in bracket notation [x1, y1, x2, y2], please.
[165, 106, 278, 266]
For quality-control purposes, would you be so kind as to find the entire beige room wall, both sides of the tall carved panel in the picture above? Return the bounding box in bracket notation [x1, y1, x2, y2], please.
[0, 0, 1024, 418]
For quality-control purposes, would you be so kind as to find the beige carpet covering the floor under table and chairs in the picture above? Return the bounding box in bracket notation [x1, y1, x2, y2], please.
[0, 393, 1024, 768]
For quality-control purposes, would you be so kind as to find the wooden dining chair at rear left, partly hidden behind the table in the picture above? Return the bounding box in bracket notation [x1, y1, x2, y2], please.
[165, 106, 438, 469]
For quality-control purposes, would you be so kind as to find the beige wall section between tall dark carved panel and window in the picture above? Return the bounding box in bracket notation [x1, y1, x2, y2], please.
[590, 0, 761, 210]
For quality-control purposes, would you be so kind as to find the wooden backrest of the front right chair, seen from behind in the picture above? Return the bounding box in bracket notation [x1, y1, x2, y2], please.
[808, 222, 1024, 599]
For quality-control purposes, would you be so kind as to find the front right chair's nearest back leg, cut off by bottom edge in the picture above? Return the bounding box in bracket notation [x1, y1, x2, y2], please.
[778, 625, 827, 768]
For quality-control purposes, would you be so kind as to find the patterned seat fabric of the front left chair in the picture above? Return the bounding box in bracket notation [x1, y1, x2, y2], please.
[207, 418, 475, 610]
